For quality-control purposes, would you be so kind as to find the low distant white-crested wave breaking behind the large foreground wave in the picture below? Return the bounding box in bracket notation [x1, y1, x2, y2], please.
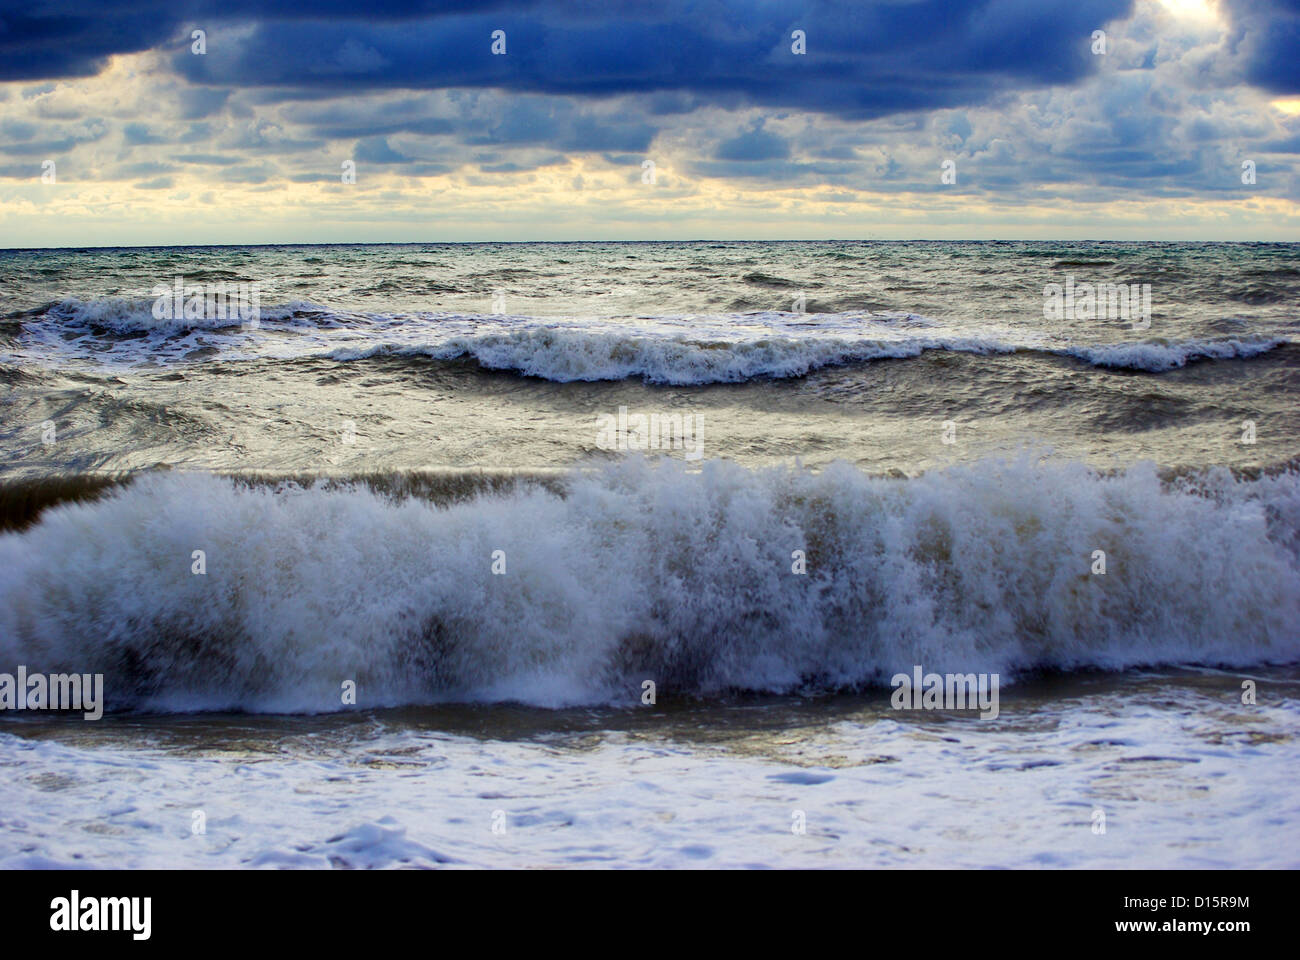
[12, 298, 1291, 386]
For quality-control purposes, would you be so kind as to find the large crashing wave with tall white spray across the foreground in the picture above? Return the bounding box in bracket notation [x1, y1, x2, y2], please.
[0, 458, 1300, 712]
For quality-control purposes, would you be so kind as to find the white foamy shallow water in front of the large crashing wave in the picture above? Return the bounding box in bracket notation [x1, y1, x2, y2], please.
[0, 669, 1300, 868]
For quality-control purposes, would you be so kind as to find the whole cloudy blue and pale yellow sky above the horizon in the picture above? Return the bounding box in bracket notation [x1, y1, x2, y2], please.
[0, 0, 1300, 247]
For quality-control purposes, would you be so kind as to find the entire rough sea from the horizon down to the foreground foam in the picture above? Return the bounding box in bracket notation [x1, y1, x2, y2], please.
[0, 242, 1300, 868]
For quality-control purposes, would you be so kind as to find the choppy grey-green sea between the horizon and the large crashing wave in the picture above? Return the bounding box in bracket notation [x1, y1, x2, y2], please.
[0, 242, 1300, 476]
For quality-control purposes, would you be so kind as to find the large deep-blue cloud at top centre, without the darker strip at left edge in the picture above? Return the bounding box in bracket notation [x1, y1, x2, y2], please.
[173, 0, 1131, 117]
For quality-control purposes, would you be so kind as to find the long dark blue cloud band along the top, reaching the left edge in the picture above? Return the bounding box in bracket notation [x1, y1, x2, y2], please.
[0, 0, 1134, 117]
